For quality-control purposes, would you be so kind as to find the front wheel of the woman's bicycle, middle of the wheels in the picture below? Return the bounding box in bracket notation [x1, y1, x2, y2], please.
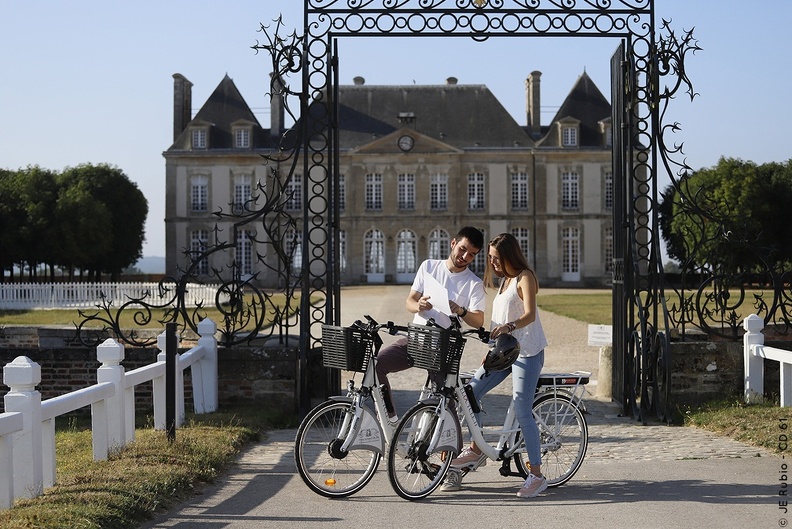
[388, 403, 454, 500]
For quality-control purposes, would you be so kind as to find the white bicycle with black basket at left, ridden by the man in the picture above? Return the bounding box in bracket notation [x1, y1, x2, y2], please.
[294, 316, 412, 498]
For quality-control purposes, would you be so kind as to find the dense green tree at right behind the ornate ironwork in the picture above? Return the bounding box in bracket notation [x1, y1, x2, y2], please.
[659, 158, 792, 273]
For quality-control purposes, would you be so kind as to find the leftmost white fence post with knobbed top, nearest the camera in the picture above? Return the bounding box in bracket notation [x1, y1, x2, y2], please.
[3, 356, 44, 498]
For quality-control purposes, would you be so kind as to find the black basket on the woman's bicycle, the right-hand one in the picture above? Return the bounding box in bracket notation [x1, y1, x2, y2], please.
[407, 323, 465, 375]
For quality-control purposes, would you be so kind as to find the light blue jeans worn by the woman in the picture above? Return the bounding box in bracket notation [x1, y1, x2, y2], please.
[470, 351, 544, 466]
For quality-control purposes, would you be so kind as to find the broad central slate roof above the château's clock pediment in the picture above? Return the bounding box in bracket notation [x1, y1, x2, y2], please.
[339, 84, 534, 149]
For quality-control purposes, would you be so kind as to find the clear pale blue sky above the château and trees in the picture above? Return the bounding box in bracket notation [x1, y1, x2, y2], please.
[0, 0, 792, 257]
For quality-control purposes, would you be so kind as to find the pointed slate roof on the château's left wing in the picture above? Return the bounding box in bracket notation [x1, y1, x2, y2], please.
[168, 74, 273, 151]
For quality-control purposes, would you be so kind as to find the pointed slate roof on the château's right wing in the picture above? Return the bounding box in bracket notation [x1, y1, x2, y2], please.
[537, 70, 611, 147]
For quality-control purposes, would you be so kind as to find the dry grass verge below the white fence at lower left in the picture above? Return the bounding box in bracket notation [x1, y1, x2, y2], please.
[0, 408, 293, 529]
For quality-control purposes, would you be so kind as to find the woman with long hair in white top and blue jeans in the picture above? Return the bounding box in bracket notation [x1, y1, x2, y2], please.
[443, 233, 547, 498]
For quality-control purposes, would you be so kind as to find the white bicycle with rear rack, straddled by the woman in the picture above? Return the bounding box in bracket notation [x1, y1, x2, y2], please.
[388, 325, 591, 500]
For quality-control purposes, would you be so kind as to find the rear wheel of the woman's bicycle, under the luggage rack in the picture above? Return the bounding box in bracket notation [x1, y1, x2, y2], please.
[514, 395, 588, 487]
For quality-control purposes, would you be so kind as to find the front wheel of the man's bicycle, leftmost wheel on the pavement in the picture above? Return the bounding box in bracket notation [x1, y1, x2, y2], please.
[294, 400, 382, 498]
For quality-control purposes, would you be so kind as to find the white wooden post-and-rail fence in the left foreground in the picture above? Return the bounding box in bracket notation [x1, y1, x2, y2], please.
[0, 319, 217, 509]
